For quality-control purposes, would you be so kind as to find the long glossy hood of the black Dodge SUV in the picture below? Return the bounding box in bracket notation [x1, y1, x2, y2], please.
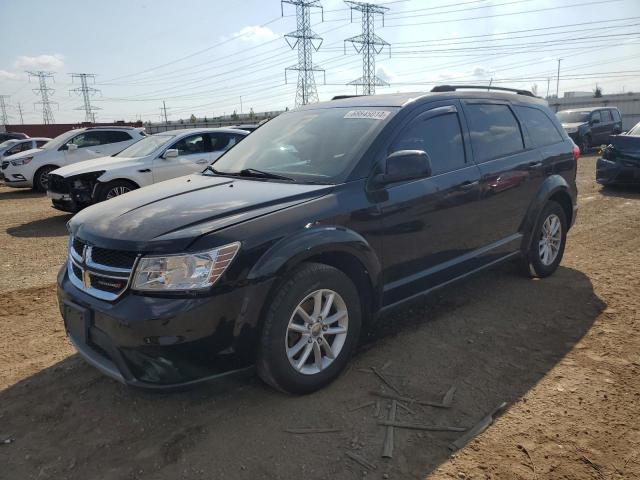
[69, 174, 333, 253]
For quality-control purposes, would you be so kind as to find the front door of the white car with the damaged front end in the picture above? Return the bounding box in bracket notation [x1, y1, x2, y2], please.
[153, 133, 211, 182]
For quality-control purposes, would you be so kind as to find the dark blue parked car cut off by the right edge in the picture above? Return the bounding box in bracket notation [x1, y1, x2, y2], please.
[596, 123, 640, 185]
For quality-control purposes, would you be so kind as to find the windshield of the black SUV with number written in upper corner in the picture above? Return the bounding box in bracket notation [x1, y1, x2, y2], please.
[208, 107, 396, 183]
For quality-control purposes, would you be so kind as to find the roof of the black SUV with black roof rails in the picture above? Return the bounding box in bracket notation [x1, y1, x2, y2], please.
[300, 89, 547, 110]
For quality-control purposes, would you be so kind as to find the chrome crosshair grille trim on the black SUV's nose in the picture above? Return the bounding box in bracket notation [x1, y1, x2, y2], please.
[67, 237, 140, 302]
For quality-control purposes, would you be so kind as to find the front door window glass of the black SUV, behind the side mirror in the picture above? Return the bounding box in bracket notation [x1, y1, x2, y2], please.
[389, 109, 466, 175]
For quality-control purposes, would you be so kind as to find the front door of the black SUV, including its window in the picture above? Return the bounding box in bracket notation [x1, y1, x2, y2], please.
[379, 101, 480, 304]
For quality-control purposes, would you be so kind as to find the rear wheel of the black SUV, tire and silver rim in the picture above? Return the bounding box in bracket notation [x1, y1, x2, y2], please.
[524, 200, 567, 278]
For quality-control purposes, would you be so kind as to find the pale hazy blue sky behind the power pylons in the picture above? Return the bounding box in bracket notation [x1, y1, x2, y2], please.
[0, 0, 640, 123]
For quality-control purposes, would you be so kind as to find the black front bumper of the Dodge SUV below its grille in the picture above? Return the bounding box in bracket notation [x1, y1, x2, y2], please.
[58, 266, 269, 390]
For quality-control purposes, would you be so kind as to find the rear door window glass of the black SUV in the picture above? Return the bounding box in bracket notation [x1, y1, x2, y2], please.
[465, 104, 524, 163]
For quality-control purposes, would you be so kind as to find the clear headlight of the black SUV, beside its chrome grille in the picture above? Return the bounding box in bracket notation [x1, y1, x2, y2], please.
[132, 242, 240, 291]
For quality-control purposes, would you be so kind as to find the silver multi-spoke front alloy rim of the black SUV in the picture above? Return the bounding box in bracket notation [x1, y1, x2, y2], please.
[285, 289, 349, 375]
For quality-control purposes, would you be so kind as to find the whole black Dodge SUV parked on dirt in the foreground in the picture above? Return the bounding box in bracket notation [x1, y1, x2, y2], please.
[58, 86, 579, 393]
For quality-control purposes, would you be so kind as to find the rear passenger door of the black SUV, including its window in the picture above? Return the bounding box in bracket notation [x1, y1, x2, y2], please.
[463, 100, 545, 248]
